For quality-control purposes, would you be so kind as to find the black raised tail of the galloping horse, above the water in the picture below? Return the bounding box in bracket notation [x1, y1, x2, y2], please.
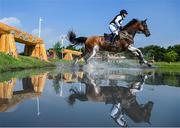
[67, 31, 87, 45]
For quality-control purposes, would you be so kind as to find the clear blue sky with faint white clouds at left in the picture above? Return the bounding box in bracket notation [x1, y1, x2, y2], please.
[0, 0, 180, 50]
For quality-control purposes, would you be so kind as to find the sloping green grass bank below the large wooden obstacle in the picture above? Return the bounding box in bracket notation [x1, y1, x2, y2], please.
[0, 53, 55, 72]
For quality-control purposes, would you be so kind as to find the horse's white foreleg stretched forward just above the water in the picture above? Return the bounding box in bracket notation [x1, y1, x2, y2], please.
[128, 45, 151, 67]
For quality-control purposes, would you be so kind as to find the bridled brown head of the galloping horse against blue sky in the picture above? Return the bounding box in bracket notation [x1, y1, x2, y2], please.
[138, 19, 151, 37]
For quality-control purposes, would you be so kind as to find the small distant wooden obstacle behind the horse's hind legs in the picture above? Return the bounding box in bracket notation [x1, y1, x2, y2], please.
[62, 49, 82, 60]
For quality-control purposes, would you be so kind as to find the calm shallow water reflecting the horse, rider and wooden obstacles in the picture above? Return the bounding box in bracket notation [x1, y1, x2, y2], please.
[0, 65, 180, 127]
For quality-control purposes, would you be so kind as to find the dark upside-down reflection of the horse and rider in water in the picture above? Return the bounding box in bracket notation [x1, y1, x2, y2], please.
[68, 74, 153, 126]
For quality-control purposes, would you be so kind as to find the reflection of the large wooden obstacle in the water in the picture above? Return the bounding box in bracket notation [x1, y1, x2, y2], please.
[0, 73, 47, 112]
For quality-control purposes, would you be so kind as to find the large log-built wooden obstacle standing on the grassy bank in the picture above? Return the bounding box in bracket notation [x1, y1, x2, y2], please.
[0, 23, 47, 61]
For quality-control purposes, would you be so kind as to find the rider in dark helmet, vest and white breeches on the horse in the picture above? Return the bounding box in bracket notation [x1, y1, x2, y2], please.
[109, 9, 128, 43]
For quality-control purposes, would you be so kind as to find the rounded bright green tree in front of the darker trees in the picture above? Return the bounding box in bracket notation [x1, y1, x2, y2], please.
[164, 50, 178, 62]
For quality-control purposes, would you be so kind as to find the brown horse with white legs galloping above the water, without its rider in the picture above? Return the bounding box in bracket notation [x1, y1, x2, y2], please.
[67, 19, 151, 67]
